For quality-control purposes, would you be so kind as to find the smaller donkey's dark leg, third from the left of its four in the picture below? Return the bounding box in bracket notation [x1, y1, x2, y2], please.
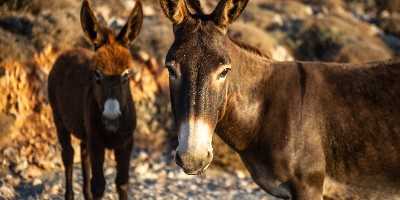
[90, 143, 106, 199]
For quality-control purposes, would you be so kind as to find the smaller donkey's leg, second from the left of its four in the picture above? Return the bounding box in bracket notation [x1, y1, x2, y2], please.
[81, 142, 93, 200]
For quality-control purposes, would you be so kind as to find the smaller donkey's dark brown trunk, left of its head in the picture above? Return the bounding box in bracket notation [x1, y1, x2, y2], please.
[48, 48, 93, 137]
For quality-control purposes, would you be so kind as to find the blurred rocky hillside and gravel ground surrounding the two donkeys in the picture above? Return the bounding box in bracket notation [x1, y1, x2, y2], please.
[0, 0, 400, 199]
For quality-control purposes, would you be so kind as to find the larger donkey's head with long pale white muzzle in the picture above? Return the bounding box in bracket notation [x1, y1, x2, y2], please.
[160, 0, 248, 174]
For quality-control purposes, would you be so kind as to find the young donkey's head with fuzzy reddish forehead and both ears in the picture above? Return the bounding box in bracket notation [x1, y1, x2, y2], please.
[81, 0, 143, 132]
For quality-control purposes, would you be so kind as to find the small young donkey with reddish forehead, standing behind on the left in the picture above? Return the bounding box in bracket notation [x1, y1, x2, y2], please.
[48, 0, 143, 199]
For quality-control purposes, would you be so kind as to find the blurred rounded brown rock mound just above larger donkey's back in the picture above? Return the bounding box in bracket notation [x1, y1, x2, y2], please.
[294, 15, 393, 63]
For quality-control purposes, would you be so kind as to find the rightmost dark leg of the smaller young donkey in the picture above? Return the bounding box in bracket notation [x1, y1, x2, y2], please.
[114, 139, 133, 200]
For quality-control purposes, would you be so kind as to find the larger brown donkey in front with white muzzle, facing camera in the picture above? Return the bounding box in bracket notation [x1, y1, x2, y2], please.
[161, 0, 400, 200]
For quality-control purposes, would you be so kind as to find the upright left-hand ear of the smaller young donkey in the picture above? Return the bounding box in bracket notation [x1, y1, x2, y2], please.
[81, 0, 103, 46]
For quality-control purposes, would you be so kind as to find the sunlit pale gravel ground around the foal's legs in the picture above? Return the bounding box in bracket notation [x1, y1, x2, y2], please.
[0, 152, 274, 200]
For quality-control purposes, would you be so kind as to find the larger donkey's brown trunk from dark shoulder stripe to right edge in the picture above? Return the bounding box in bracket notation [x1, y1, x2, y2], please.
[288, 61, 400, 186]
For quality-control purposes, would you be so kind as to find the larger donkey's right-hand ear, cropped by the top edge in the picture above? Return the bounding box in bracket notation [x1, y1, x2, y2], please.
[212, 0, 249, 28]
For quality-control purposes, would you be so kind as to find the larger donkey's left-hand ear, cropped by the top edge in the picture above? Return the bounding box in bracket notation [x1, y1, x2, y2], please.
[160, 0, 190, 24]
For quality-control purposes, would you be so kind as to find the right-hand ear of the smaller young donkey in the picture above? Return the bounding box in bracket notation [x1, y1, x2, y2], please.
[117, 0, 143, 44]
